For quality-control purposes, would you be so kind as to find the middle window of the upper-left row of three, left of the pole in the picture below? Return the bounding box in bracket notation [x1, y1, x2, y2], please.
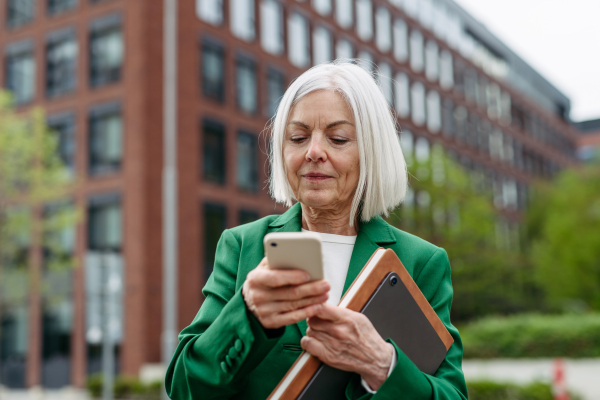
[46, 28, 78, 97]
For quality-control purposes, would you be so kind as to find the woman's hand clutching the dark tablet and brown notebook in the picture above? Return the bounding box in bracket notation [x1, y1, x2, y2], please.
[300, 303, 396, 390]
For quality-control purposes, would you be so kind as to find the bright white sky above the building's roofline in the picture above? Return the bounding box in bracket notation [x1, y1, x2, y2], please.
[454, 0, 600, 122]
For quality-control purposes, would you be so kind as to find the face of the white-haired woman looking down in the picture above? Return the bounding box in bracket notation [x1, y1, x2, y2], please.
[283, 90, 359, 211]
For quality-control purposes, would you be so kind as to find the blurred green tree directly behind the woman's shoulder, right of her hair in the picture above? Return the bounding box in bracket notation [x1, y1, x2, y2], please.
[388, 146, 539, 321]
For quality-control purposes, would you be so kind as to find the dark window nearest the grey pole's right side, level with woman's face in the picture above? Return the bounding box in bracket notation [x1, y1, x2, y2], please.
[203, 119, 226, 185]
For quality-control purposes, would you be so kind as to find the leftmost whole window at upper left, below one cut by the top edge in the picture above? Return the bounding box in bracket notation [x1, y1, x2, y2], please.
[5, 40, 35, 104]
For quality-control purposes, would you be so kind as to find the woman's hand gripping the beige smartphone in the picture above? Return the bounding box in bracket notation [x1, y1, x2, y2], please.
[242, 257, 329, 329]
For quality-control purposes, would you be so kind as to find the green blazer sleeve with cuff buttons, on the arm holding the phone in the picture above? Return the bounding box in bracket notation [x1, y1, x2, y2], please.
[165, 230, 281, 400]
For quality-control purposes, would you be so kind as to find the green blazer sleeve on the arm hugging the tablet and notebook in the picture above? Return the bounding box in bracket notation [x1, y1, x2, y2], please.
[346, 248, 468, 400]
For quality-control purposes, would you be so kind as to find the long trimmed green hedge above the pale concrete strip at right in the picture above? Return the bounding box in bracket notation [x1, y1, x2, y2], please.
[460, 313, 600, 358]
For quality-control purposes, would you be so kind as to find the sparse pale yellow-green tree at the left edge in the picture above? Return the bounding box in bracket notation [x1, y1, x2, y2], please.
[0, 91, 79, 382]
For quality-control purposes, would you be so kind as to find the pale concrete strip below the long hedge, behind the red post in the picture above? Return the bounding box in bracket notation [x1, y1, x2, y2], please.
[463, 358, 600, 400]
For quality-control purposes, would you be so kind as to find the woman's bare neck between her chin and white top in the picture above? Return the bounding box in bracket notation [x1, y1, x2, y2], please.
[300, 204, 358, 236]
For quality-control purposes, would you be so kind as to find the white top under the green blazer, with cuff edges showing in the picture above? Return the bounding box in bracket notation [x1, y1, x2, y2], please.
[302, 229, 397, 393]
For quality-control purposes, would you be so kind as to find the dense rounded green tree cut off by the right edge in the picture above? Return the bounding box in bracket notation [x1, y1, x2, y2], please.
[527, 165, 600, 310]
